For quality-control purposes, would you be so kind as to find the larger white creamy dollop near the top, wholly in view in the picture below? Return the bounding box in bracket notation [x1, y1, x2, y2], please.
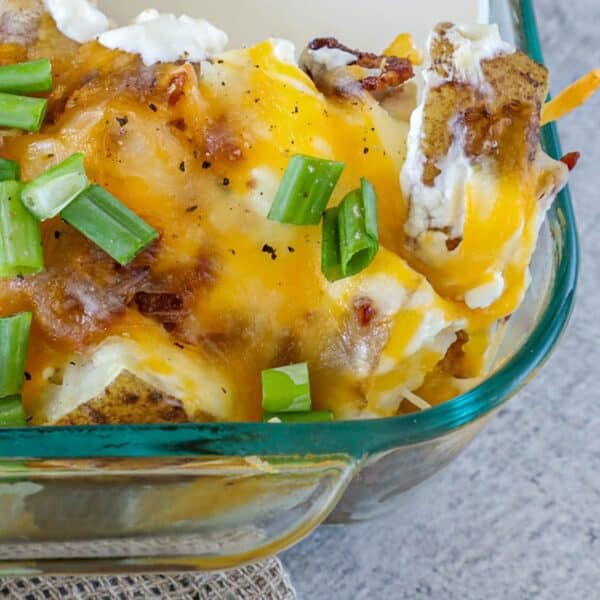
[98, 9, 229, 66]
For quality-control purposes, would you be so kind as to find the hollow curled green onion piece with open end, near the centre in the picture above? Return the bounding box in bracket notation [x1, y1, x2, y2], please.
[321, 178, 379, 281]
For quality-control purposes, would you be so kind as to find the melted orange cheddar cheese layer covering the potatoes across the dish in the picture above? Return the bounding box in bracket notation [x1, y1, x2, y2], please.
[0, 17, 592, 424]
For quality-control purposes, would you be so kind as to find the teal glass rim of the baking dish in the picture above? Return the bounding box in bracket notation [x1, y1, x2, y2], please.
[0, 0, 579, 459]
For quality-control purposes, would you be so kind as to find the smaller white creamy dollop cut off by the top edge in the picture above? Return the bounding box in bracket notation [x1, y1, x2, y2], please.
[44, 0, 110, 44]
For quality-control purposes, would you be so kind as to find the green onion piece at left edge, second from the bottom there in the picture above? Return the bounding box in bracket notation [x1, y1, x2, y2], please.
[0, 313, 32, 398]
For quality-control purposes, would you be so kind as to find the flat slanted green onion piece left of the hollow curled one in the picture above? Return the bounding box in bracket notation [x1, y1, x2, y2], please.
[268, 154, 345, 225]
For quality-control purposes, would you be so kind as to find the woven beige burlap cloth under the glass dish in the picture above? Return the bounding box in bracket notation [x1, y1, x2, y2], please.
[0, 558, 296, 600]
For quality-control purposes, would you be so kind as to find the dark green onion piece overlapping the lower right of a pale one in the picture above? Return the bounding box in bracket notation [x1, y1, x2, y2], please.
[61, 185, 158, 265]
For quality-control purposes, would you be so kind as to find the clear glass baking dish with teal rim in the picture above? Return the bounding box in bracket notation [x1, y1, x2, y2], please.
[0, 0, 578, 575]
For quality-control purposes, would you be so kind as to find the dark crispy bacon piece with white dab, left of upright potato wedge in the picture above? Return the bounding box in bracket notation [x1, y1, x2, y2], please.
[301, 37, 414, 95]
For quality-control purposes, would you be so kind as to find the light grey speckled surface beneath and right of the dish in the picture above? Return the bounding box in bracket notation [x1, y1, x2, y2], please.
[282, 0, 600, 600]
